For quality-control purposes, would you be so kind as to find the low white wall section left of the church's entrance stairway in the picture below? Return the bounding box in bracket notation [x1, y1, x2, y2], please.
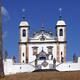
[3, 59, 35, 75]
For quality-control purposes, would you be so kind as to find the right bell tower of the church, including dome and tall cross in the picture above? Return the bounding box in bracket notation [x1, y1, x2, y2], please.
[56, 9, 66, 62]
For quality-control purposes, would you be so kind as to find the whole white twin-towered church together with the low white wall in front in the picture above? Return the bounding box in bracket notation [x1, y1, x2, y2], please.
[3, 16, 80, 75]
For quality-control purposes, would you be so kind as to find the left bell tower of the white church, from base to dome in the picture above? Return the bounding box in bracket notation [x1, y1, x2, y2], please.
[19, 17, 29, 64]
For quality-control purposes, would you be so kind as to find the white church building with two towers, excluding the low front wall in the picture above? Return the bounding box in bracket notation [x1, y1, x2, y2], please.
[19, 15, 66, 64]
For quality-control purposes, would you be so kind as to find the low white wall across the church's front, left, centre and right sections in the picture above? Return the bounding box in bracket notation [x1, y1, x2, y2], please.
[3, 59, 80, 75]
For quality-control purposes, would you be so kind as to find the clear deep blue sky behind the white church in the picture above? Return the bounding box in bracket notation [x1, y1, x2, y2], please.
[3, 0, 80, 60]
